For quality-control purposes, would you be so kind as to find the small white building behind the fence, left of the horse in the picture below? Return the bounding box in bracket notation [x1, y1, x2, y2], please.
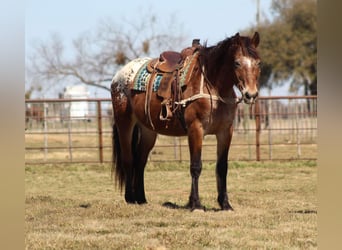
[63, 84, 90, 120]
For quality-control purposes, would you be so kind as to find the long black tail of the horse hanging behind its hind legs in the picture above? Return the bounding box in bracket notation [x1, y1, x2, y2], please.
[111, 123, 141, 191]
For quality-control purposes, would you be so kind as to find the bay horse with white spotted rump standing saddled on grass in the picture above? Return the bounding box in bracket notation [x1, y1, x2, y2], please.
[111, 32, 260, 211]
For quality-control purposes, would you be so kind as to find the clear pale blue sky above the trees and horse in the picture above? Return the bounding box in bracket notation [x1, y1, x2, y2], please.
[25, 0, 288, 97]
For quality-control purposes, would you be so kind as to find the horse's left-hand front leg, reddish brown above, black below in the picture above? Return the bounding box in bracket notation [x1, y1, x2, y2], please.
[188, 124, 204, 210]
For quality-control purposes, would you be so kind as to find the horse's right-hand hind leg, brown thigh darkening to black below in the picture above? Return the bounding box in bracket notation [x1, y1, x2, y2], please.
[133, 127, 157, 204]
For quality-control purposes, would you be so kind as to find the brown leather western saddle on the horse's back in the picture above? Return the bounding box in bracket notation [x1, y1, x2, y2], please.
[145, 39, 201, 123]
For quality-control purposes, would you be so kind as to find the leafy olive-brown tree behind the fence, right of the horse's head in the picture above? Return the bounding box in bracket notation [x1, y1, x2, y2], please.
[258, 0, 317, 95]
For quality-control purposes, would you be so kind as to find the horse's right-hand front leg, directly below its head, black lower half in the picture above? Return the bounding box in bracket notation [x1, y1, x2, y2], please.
[216, 125, 233, 210]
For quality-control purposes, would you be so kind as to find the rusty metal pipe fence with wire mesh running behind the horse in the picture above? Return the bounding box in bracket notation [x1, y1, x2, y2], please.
[25, 96, 317, 164]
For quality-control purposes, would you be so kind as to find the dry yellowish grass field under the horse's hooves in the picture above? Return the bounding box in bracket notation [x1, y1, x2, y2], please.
[25, 161, 317, 249]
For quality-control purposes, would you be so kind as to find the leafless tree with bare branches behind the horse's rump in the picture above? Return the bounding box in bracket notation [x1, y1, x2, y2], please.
[27, 11, 186, 96]
